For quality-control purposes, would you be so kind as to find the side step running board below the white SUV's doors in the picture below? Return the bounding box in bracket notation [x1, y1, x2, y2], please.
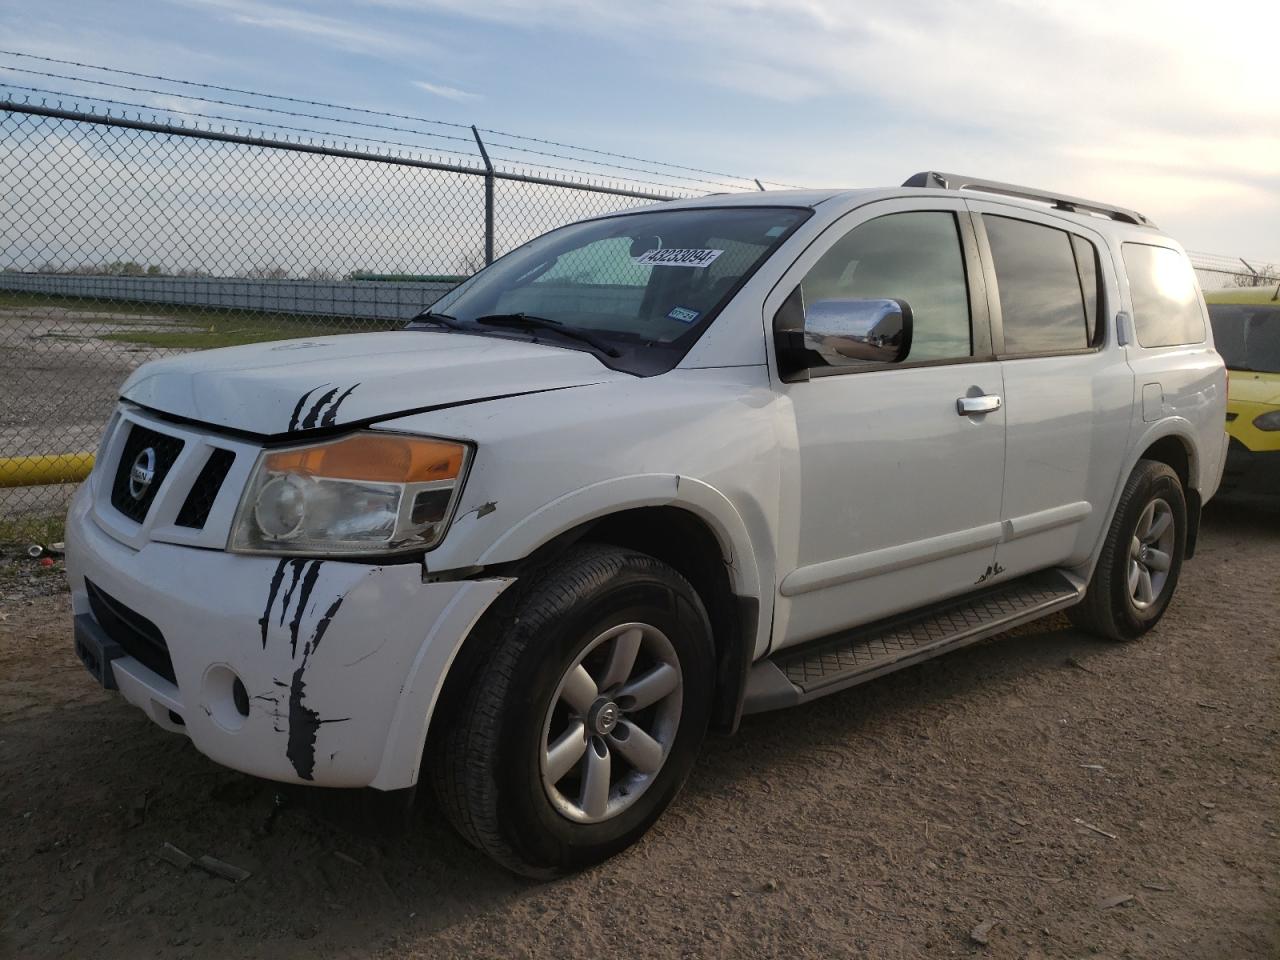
[742, 571, 1084, 713]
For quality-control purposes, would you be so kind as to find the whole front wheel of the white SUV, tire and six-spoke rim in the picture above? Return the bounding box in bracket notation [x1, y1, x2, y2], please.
[431, 544, 714, 877]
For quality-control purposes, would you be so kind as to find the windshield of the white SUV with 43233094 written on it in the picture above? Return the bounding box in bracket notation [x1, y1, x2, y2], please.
[415, 206, 810, 374]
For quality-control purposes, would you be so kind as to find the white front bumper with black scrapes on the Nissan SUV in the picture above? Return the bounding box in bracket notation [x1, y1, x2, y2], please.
[67, 479, 511, 790]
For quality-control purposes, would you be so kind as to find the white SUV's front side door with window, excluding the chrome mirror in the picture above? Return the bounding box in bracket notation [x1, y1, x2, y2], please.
[765, 198, 1005, 649]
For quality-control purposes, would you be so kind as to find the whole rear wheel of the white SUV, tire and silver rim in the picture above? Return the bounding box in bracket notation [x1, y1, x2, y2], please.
[1068, 460, 1187, 640]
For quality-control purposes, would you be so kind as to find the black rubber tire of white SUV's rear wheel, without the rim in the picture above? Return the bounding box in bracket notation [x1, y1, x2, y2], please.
[1068, 460, 1187, 641]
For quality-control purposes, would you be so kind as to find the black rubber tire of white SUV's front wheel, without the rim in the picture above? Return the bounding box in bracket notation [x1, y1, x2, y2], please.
[428, 544, 714, 879]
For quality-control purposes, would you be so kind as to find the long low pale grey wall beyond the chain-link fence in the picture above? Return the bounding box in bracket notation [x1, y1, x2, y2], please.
[0, 273, 452, 320]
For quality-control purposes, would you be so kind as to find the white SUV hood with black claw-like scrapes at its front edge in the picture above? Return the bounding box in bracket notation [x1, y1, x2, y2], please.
[120, 330, 630, 436]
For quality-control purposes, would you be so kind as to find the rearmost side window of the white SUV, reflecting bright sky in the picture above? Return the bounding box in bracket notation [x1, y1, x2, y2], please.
[1121, 243, 1204, 347]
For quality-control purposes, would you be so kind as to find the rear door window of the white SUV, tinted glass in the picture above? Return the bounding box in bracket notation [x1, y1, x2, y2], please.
[982, 214, 1098, 356]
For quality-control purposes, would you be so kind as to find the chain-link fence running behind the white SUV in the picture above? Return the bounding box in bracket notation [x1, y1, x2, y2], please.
[0, 97, 1280, 552]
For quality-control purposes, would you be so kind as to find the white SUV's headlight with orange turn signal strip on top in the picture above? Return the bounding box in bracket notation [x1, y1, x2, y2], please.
[228, 433, 471, 554]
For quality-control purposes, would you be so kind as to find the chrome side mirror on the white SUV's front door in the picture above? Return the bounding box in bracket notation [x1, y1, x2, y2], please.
[803, 300, 911, 366]
